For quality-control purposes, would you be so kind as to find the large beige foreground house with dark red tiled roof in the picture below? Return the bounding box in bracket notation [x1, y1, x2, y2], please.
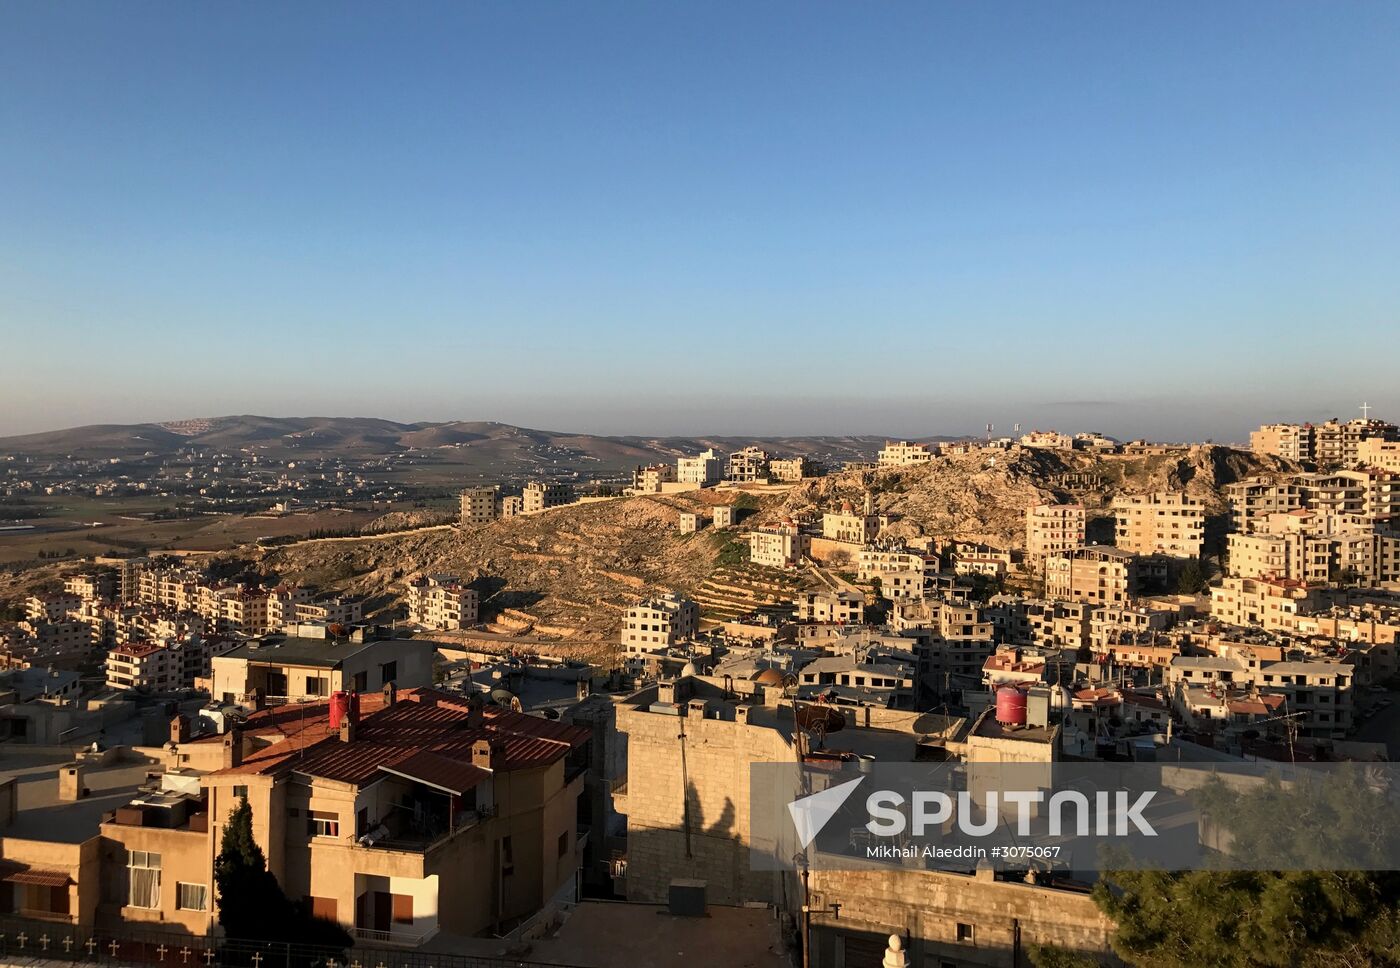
[193, 689, 591, 944]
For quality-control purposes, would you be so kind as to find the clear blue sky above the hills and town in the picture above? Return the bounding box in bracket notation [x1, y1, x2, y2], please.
[0, 0, 1400, 440]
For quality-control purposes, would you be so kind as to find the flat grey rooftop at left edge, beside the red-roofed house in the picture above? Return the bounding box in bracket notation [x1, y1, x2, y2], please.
[0, 747, 161, 843]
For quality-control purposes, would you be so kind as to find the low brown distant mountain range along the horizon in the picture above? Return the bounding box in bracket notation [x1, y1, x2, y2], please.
[0, 416, 952, 468]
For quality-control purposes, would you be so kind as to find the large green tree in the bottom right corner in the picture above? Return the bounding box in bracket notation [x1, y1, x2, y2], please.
[1093, 765, 1400, 968]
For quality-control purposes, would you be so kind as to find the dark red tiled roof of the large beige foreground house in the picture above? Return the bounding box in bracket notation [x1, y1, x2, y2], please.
[221, 689, 591, 783]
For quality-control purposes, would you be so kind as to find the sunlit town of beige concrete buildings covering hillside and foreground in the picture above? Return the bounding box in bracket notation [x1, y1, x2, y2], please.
[0, 419, 1400, 967]
